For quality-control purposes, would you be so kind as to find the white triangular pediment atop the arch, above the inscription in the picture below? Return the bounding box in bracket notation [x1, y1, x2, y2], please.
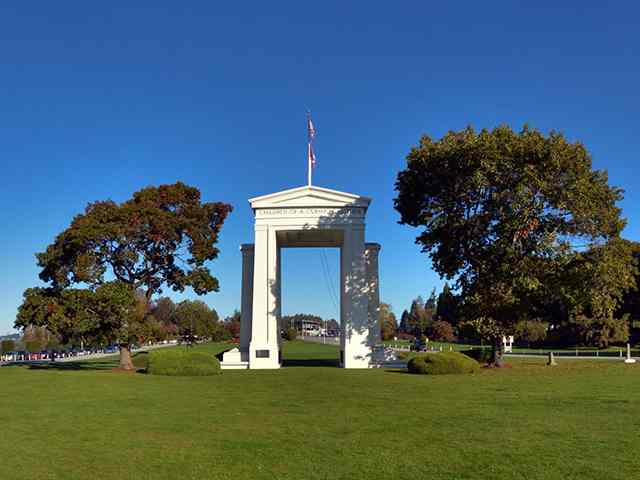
[249, 186, 371, 209]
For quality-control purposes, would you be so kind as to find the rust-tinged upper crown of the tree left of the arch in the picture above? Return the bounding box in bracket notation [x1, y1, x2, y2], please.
[36, 182, 232, 298]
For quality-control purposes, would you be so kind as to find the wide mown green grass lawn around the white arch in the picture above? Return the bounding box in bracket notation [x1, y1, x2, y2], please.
[0, 342, 640, 479]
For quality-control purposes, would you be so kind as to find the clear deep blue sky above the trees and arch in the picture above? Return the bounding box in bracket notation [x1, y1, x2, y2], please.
[0, 0, 640, 333]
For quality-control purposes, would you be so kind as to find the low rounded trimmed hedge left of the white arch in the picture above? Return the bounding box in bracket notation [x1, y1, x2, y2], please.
[147, 347, 222, 377]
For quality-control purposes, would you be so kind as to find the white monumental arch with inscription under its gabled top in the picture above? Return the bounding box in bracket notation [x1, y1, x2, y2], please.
[222, 185, 383, 369]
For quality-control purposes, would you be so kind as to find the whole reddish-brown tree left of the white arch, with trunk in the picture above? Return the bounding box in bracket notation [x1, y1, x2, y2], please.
[16, 182, 232, 369]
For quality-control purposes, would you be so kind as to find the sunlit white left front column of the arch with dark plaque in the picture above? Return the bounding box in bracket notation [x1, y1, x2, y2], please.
[249, 225, 280, 368]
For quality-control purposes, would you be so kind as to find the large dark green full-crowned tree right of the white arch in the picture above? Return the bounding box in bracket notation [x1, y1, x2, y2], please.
[395, 126, 631, 365]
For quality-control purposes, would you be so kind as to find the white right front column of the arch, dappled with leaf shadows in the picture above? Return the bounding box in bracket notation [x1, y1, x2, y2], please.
[341, 225, 371, 368]
